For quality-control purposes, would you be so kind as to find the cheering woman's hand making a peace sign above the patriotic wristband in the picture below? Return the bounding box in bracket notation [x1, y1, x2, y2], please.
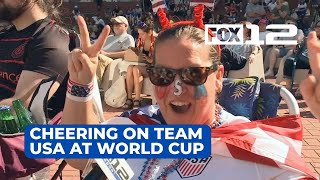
[68, 16, 110, 85]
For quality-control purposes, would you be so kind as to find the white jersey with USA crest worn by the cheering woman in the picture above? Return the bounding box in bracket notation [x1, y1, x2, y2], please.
[87, 111, 310, 180]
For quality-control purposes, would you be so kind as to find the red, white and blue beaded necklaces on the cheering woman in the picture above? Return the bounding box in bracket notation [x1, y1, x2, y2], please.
[138, 104, 222, 180]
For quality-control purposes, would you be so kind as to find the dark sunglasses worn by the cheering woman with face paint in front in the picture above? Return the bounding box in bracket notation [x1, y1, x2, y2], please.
[147, 63, 219, 86]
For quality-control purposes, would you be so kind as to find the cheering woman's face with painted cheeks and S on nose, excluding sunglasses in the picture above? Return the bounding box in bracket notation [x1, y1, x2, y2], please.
[155, 37, 224, 124]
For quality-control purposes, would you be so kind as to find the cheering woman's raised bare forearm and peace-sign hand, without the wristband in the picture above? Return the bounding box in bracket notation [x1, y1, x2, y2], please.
[61, 16, 110, 169]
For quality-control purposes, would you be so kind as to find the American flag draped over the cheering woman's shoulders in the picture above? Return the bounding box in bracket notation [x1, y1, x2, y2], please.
[122, 106, 318, 180]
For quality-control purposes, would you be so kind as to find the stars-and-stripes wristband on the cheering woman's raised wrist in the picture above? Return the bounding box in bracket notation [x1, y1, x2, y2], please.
[67, 79, 94, 102]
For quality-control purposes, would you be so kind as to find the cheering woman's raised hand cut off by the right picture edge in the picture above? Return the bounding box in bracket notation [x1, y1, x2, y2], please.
[300, 32, 320, 120]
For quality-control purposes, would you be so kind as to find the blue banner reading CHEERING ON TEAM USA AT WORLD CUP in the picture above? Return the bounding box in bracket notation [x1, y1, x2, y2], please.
[25, 125, 211, 158]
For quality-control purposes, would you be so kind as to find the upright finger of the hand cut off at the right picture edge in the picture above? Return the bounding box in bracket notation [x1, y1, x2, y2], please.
[307, 32, 320, 78]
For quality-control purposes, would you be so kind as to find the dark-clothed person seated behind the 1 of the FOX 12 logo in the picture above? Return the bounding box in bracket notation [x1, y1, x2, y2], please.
[221, 21, 261, 76]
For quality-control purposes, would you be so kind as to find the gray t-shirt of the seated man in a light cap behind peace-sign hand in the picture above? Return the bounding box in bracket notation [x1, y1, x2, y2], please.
[103, 33, 135, 52]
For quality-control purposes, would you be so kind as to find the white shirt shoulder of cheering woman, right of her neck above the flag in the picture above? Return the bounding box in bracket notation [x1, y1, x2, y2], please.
[219, 110, 250, 127]
